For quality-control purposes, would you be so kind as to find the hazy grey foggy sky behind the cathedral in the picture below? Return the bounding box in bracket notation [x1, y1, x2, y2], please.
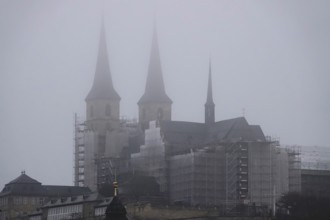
[0, 0, 330, 188]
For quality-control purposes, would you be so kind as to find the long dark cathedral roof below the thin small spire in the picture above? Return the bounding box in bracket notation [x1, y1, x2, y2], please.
[160, 117, 266, 154]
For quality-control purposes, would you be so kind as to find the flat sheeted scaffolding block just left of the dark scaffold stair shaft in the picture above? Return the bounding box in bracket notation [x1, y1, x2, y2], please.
[169, 145, 225, 206]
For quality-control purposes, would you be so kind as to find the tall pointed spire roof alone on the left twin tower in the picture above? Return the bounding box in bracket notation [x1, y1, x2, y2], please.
[86, 17, 120, 101]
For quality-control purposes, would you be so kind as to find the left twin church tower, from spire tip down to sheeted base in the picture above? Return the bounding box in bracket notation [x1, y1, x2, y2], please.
[83, 20, 123, 191]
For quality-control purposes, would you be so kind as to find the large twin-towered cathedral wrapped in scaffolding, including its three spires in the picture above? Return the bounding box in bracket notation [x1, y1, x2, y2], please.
[74, 21, 289, 209]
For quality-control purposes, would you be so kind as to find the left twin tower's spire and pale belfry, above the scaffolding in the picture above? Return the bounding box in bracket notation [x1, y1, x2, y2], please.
[85, 21, 120, 135]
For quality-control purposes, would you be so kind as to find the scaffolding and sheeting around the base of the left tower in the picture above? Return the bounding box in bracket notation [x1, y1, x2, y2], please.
[73, 114, 141, 190]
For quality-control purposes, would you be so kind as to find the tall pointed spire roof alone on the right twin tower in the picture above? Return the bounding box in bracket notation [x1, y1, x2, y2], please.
[138, 26, 172, 104]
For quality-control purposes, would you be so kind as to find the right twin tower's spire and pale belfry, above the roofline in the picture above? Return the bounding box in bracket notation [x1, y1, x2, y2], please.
[138, 28, 172, 130]
